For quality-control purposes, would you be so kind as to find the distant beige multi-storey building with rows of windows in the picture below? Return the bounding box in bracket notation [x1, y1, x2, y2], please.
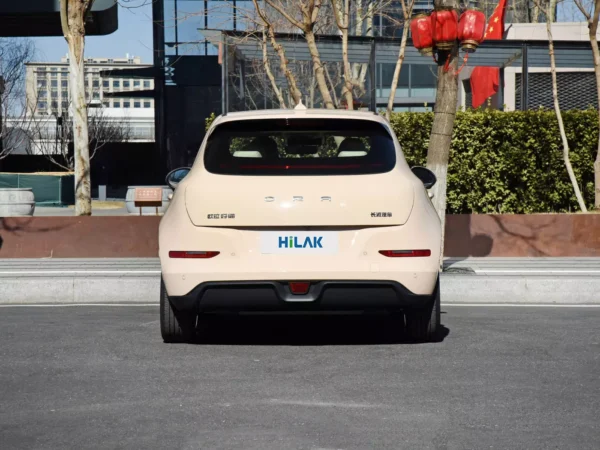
[25, 55, 154, 117]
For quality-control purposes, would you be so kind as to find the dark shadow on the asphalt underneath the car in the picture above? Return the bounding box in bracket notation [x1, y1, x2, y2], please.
[194, 314, 450, 346]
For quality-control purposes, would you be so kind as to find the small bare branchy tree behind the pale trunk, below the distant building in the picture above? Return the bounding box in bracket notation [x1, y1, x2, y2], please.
[29, 104, 132, 172]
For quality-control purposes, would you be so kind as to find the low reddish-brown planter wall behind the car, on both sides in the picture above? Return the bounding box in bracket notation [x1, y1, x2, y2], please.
[0, 214, 600, 258]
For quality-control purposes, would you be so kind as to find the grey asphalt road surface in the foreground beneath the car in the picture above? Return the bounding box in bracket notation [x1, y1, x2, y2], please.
[0, 306, 600, 450]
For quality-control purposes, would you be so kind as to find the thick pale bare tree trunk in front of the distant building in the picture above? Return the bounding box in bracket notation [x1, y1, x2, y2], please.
[60, 0, 93, 216]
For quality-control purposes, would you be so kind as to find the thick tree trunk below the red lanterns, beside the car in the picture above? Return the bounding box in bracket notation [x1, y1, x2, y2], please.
[427, 0, 460, 270]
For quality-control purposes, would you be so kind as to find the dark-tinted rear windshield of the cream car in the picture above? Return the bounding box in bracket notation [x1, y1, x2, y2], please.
[204, 119, 396, 175]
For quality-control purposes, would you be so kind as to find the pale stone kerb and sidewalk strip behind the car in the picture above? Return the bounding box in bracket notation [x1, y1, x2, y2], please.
[0, 258, 600, 305]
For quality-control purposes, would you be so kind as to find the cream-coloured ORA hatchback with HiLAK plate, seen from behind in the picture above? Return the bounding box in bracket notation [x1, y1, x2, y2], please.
[159, 106, 441, 342]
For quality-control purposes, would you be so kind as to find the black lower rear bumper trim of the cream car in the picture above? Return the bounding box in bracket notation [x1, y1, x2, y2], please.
[169, 280, 431, 312]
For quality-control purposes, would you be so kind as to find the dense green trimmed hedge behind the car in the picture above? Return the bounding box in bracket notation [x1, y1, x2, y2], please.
[207, 109, 598, 214]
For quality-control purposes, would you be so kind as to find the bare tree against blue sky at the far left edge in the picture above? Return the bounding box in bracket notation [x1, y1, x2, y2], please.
[0, 39, 36, 159]
